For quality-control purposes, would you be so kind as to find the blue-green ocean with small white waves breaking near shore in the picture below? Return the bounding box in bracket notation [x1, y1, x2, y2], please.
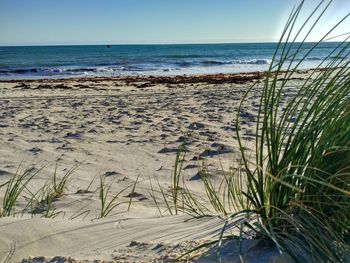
[0, 42, 339, 79]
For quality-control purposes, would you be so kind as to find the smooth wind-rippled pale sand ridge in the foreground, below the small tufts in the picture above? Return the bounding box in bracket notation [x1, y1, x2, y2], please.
[0, 216, 222, 262]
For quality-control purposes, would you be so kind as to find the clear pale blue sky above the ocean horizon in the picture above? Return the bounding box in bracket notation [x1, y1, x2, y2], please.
[0, 0, 350, 45]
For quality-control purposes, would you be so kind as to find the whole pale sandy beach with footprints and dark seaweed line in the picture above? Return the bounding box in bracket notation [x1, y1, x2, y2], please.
[0, 72, 307, 262]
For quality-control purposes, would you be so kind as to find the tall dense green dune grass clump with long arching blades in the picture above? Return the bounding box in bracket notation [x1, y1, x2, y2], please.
[171, 1, 350, 262]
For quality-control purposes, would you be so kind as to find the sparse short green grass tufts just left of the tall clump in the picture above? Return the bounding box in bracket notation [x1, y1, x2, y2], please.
[154, 143, 234, 217]
